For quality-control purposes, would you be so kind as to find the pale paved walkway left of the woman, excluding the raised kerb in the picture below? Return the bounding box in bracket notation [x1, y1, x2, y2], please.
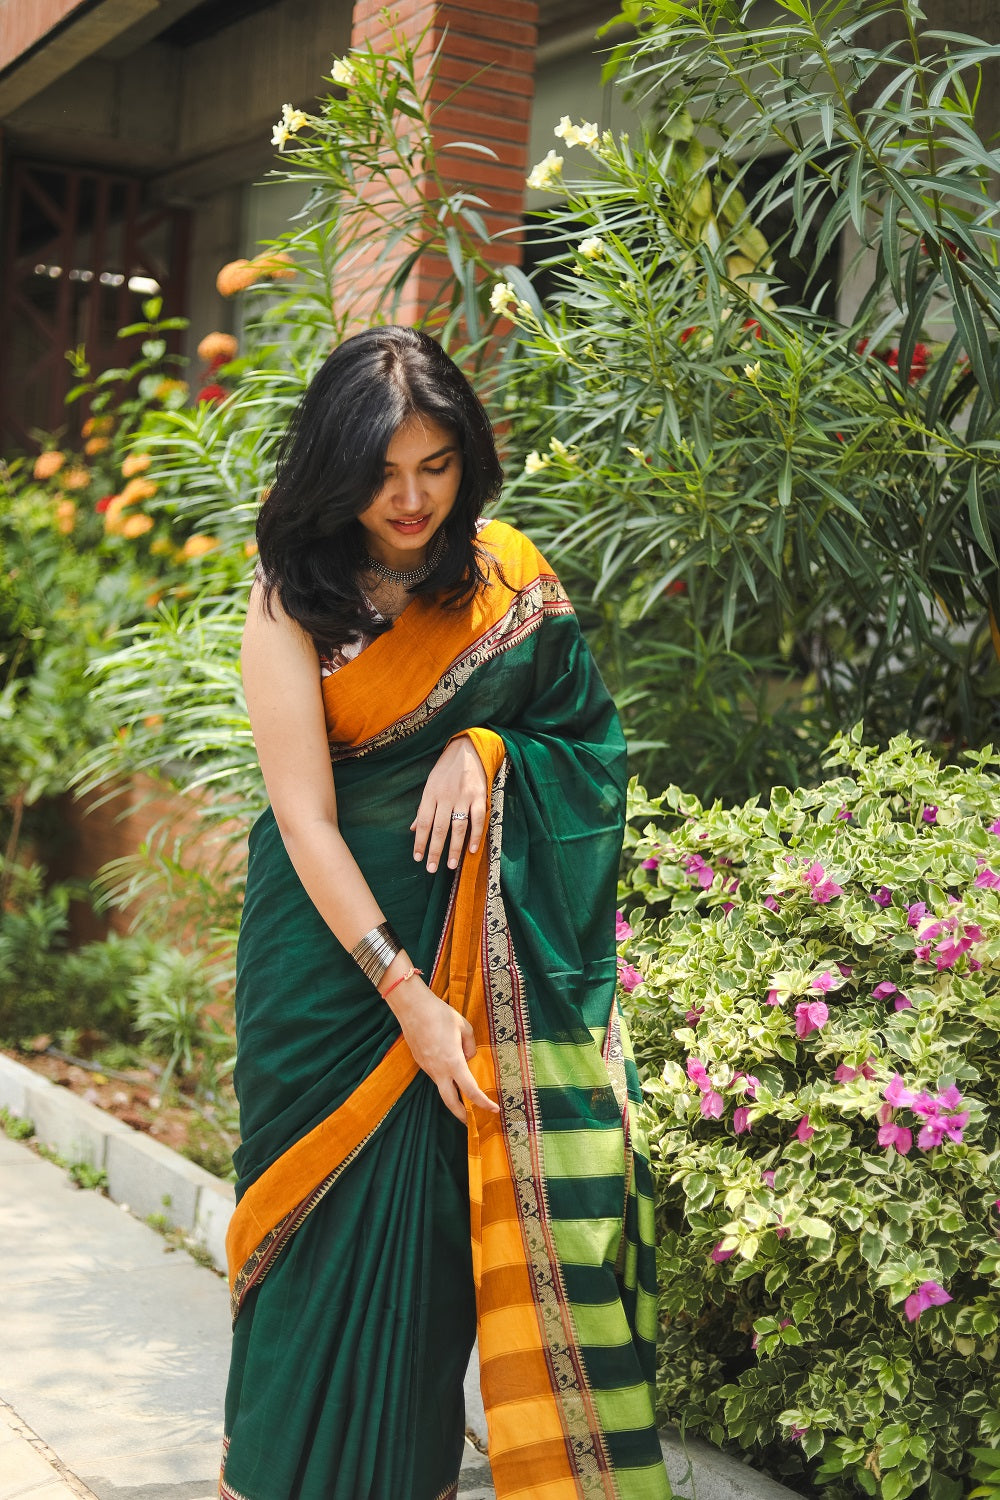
[0, 1133, 493, 1500]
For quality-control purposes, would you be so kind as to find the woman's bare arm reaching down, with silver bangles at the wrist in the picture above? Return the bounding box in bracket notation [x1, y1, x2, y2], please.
[241, 584, 495, 1121]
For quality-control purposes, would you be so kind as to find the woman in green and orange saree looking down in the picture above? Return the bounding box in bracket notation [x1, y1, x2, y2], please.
[222, 329, 669, 1500]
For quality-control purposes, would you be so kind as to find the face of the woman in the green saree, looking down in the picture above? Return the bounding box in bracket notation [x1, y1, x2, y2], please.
[358, 413, 462, 573]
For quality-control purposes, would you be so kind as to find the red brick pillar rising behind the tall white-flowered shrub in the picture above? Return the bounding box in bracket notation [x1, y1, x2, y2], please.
[351, 0, 538, 324]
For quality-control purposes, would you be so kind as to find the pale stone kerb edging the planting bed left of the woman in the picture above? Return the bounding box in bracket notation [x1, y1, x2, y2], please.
[0, 1056, 235, 1271]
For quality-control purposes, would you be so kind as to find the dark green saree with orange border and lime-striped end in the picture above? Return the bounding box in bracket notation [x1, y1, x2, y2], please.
[222, 522, 670, 1500]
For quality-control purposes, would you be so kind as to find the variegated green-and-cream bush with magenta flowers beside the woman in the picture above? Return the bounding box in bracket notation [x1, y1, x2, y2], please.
[619, 731, 1000, 1500]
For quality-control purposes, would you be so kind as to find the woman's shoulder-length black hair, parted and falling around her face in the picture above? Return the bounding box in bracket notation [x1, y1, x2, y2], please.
[256, 327, 504, 653]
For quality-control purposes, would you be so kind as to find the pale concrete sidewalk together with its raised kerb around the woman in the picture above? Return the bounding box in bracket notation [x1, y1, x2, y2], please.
[0, 1056, 790, 1500]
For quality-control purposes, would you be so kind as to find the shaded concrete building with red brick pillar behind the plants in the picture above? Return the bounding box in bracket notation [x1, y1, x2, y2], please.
[0, 0, 638, 447]
